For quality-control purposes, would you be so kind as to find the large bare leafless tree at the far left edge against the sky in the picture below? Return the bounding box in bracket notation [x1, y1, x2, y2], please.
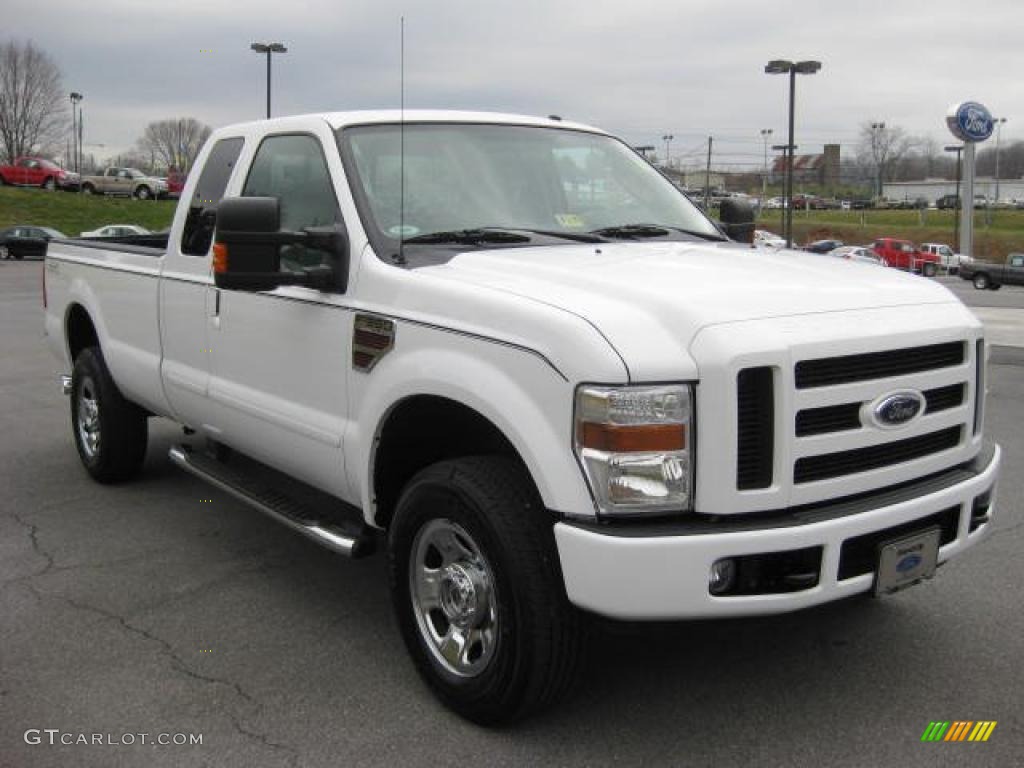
[0, 41, 68, 163]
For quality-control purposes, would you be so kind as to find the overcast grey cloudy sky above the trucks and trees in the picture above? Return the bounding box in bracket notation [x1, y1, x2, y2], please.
[6, 0, 1024, 167]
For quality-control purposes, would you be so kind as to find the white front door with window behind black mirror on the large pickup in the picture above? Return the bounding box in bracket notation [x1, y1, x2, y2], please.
[203, 124, 352, 497]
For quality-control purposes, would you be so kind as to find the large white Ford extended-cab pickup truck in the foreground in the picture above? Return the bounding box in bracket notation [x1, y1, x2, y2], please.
[44, 112, 999, 723]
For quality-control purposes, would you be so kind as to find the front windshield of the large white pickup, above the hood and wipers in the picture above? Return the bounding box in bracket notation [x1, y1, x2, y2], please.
[339, 124, 721, 247]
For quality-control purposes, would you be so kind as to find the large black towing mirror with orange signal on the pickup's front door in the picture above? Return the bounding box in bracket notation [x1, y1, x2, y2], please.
[213, 198, 348, 293]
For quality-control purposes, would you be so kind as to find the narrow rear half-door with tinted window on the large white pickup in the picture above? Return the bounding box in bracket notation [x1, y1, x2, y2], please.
[160, 137, 244, 430]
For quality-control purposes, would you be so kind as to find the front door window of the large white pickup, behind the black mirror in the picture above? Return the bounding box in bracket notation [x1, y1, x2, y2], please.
[242, 135, 341, 270]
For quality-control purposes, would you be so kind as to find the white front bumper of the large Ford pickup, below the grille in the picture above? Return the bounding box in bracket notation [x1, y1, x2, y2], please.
[555, 445, 1001, 620]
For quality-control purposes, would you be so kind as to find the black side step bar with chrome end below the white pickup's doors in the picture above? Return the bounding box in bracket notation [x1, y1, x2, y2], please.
[169, 445, 374, 558]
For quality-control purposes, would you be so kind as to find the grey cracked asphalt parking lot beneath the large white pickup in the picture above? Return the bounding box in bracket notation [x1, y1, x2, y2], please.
[0, 262, 1024, 768]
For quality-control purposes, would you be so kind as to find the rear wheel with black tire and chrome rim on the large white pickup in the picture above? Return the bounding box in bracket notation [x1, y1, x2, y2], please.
[71, 347, 148, 483]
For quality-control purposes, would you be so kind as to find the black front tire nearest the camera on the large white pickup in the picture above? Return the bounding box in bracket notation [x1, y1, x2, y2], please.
[388, 457, 583, 725]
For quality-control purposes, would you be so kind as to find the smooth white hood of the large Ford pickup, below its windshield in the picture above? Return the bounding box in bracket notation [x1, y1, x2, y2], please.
[421, 242, 958, 380]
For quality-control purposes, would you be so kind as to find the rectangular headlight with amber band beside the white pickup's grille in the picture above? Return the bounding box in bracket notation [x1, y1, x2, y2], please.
[573, 384, 693, 515]
